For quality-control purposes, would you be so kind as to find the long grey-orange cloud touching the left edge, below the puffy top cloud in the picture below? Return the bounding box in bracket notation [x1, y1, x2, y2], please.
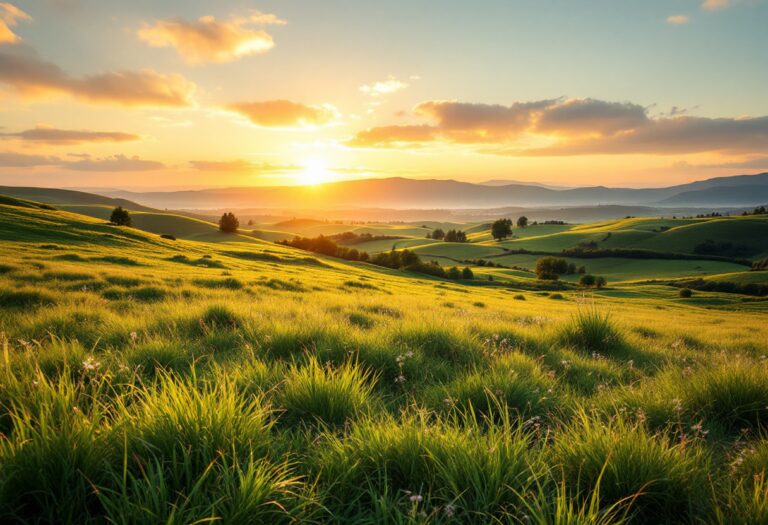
[0, 50, 196, 107]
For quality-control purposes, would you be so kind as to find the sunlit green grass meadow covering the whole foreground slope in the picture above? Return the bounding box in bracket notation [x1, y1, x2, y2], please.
[0, 200, 768, 524]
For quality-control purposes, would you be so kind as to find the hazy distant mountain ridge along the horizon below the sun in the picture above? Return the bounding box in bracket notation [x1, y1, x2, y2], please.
[94, 173, 768, 209]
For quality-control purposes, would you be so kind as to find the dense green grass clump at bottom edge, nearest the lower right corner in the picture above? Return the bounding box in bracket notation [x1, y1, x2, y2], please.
[554, 413, 709, 523]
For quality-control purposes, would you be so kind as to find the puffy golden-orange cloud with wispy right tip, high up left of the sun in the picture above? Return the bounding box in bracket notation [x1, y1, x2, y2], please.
[138, 13, 285, 64]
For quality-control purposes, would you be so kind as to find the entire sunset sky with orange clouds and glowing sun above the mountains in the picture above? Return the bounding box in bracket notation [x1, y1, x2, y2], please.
[0, 0, 768, 190]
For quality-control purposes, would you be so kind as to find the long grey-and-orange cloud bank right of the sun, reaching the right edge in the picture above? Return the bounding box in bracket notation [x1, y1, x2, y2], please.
[346, 98, 768, 156]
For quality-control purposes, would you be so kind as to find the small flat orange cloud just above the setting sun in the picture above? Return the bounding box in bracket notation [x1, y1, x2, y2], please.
[226, 100, 339, 128]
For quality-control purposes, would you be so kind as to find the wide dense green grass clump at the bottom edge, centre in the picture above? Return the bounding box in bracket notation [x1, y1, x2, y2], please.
[312, 412, 544, 522]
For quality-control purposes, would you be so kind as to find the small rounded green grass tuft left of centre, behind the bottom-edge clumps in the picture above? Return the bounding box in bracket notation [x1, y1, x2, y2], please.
[278, 357, 376, 425]
